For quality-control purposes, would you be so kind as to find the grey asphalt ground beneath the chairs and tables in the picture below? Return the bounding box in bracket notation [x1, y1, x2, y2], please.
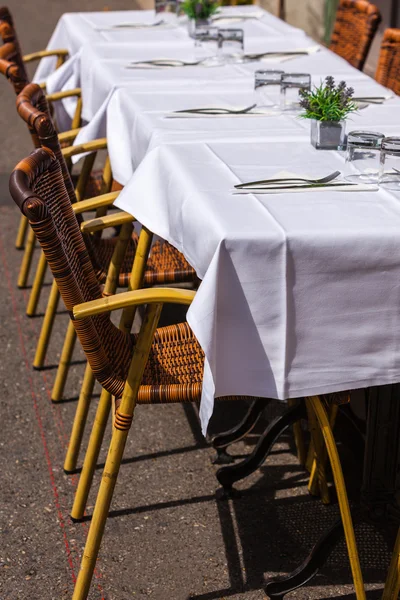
[0, 0, 389, 600]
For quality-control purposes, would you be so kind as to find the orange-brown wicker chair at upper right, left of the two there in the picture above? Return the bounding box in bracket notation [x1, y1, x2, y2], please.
[329, 0, 381, 71]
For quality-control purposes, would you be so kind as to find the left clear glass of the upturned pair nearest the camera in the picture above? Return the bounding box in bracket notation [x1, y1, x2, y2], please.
[343, 131, 385, 183]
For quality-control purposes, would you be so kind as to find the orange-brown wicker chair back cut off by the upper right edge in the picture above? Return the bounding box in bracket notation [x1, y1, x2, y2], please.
[375, 29, 400, 94]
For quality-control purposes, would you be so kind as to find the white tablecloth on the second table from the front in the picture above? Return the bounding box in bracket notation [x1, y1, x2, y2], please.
[105, 79, 400, 185]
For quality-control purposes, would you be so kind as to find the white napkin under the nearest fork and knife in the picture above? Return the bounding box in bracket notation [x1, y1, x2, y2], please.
[231, 171, 379, 195]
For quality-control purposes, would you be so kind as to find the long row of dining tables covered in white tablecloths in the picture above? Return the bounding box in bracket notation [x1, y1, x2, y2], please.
[36, 6, 400, 597]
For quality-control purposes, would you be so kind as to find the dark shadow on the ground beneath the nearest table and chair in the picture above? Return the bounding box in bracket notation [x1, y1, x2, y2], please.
[84, 412, 390, 600]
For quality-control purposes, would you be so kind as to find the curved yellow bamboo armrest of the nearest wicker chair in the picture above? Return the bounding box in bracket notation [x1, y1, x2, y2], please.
[73, 288, 196, 319]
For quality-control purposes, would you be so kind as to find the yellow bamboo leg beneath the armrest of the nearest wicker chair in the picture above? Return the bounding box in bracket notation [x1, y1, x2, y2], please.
[72, 304, 162, 600]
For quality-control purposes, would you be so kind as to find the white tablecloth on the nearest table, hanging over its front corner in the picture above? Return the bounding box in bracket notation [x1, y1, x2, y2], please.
[116, 139, 400, 429]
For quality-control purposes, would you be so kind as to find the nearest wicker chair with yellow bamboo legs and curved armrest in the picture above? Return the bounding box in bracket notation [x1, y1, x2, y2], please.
[10, 148, 365, 600]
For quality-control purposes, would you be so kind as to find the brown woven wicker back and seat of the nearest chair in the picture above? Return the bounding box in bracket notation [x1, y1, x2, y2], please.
[10, 148, 244, 403]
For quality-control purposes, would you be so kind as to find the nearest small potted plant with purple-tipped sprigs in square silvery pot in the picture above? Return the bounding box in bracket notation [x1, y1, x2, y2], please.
[299, 76, 357, 150]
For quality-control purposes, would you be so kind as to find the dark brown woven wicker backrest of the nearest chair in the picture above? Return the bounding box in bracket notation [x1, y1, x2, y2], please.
[10, 148, 133, 397]
